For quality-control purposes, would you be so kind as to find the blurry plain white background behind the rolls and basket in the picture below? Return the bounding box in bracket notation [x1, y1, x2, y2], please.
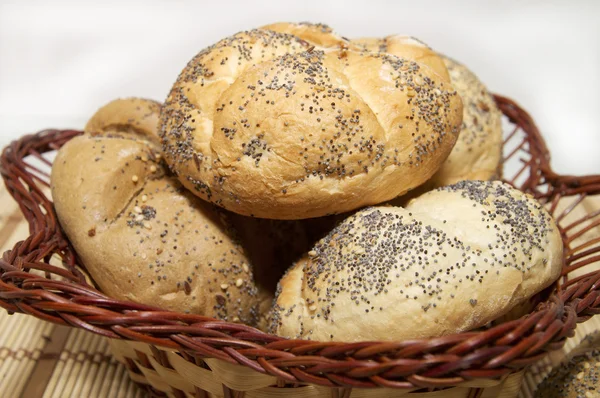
[0, 0, 600, 174]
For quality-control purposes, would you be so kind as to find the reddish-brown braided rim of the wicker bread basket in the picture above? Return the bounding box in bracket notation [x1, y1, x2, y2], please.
[0, 95, 600, 388]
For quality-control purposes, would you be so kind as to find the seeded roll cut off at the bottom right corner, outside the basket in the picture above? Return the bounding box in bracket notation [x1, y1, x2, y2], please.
[535, 335, 600, 398]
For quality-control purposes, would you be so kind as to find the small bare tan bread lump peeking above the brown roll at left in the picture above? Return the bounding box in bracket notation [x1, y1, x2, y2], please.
[84, 98, 161, 144]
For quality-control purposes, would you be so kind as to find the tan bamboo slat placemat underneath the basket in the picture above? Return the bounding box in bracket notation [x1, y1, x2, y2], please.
[0, 180, 600, 398]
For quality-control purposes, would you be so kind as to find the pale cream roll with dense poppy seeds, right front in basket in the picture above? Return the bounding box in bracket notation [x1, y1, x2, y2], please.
[270, 181, 562, 342]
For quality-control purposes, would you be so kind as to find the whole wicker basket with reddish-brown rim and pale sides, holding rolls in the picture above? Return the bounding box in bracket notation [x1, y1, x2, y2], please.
[0, 96, 600, 398]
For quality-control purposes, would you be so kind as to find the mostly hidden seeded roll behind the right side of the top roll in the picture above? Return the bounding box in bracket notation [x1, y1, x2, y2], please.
[352, 36, 502, 190]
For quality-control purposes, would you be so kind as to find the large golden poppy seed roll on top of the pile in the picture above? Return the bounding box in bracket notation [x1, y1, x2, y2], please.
[160, 29, 462, 219]
